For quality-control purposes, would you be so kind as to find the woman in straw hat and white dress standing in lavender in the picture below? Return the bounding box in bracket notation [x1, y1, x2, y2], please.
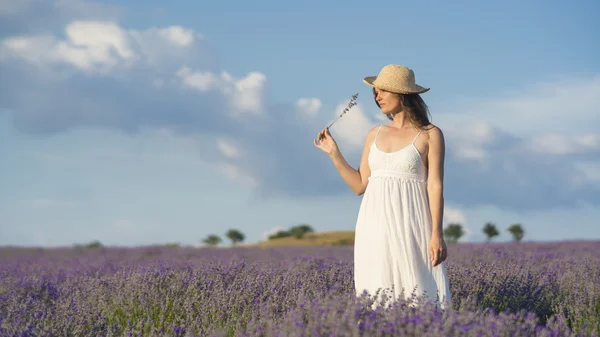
[314, 64, 451, 308]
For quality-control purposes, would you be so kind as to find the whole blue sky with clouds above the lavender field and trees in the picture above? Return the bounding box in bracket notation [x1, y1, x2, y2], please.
[0, 0, 600, 246]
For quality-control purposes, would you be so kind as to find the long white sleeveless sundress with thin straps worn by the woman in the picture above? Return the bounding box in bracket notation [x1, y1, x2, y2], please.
[354, 126, 451, 308]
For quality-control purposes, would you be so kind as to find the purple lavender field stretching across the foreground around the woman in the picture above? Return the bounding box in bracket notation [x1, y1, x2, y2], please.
[0, 242, 600, 336]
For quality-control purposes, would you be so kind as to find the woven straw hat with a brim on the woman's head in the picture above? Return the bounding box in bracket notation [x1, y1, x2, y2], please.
[363, 64, 429, 94]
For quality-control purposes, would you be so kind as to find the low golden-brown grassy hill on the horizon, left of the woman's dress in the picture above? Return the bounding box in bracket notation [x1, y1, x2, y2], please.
[246, 231, 354, 247]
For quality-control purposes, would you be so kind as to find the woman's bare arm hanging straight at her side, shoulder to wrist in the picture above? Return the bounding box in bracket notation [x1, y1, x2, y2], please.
[427, 126, 446, 238]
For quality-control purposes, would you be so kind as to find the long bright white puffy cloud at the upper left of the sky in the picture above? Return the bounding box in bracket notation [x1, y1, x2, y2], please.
[0, 20, 209, 73]
